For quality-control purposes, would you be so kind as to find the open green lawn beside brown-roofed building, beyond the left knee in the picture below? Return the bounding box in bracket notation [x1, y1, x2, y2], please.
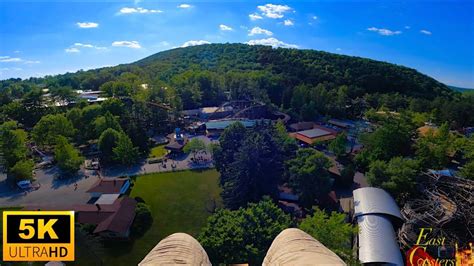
[102, 170, 221, 265]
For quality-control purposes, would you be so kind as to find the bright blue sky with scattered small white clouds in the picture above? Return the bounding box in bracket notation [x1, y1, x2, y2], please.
[0, 0, 474, 88]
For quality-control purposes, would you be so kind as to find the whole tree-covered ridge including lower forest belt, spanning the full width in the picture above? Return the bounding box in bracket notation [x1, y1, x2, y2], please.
[0, 44, 474, 127]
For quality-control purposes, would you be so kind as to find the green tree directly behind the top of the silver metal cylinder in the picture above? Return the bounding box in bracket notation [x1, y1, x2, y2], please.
[367, 157, 420, 202]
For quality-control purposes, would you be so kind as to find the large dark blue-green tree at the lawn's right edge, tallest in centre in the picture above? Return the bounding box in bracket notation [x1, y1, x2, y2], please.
[218, 124, 284, 209]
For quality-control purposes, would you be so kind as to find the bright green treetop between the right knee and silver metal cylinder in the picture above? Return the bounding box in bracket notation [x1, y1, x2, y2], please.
[298, 207, 357, 261]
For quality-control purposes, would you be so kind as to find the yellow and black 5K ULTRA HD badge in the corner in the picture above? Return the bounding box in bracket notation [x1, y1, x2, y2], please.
[3, 211, 74, 261]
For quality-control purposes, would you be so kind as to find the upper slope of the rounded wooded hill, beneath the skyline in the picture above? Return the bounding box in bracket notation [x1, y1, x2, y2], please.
[133, 44, 450, 98]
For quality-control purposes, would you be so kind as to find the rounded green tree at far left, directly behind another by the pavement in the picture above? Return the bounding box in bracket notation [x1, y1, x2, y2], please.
[32, 114, 75, 145]
